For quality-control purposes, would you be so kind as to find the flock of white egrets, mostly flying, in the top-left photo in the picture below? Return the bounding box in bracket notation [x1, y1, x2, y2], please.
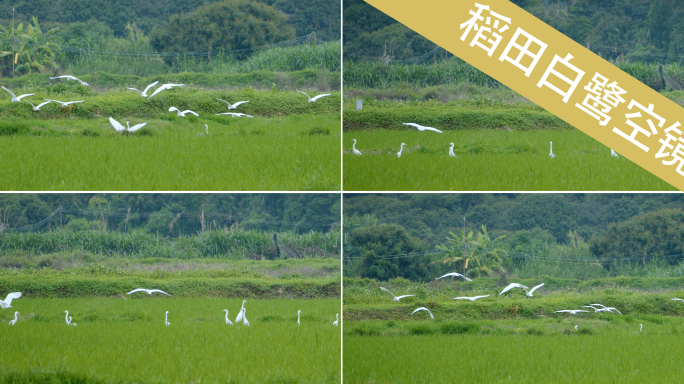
[2, 75, 330, 134]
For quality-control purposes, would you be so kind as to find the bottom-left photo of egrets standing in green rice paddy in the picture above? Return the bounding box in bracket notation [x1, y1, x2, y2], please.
[0, 193, 341, 383]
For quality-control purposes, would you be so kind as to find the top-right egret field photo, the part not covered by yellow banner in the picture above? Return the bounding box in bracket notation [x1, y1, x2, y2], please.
[343, 0, 684, 191]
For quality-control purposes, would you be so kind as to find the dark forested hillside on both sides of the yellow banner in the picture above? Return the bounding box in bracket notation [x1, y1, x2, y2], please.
[344, 0, 684, 63]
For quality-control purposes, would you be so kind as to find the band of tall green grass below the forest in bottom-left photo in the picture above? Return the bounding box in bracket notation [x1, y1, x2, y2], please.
[0, 229, 340, 259]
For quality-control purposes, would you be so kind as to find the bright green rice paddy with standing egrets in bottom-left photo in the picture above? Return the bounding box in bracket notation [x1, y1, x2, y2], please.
[0, 294, 340, 383]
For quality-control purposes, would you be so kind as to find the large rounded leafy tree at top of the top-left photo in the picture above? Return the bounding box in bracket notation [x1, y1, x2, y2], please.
[150, 0, 295, 57]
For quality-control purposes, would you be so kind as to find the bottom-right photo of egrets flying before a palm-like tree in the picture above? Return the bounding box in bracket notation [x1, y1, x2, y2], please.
[343, 193, 684, 384]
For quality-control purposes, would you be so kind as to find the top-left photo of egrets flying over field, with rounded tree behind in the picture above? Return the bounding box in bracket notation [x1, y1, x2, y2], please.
[0, 0, 341, 191]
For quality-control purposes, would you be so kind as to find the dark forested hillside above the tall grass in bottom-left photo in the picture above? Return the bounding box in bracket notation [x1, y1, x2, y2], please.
[0, 193, 340, 237]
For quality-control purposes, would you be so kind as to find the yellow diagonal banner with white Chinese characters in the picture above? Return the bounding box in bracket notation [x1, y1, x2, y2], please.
[366, 0, 684, 190]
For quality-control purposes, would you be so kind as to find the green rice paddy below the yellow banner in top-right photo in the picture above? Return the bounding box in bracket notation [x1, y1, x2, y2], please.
[343, 129, 675, 191]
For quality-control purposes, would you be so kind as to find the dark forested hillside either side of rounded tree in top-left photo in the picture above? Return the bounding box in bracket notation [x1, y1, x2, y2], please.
[0, 0, 340, 40]
